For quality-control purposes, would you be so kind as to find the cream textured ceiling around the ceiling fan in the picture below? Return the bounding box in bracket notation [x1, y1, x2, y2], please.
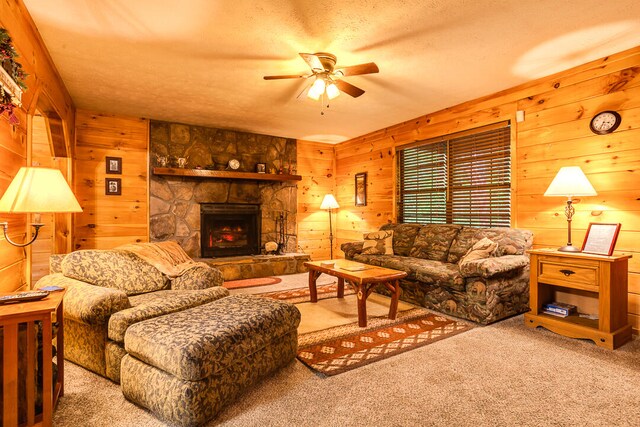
[24, 0, 640, 142]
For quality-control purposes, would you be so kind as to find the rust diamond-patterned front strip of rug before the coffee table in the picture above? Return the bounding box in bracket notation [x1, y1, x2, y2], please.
[297, 308, 472, 377]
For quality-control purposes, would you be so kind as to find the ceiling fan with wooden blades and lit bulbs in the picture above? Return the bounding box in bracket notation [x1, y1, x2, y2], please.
[264, 52, 380, 100]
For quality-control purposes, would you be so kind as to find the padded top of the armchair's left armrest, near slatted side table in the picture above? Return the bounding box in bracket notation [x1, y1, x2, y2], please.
[36, 273, 131, 325]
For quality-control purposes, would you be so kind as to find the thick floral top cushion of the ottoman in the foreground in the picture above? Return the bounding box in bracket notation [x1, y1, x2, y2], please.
[125, 295, 300, 381]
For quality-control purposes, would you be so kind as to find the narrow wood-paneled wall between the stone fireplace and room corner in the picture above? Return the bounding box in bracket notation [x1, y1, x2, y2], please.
[297, 140, 336, 260]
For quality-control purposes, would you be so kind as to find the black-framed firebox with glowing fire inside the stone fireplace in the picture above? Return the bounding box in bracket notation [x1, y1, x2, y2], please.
[200, 203, 261, 258]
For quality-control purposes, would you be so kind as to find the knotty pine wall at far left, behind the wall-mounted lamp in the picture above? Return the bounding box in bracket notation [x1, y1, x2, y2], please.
[0, 0, 75, 291]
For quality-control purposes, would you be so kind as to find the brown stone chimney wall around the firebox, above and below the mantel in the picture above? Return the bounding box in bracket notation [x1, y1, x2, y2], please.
[149, 120, 297, 258]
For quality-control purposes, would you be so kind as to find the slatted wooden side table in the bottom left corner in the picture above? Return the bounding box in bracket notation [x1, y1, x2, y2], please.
[0, 290, 65, 427]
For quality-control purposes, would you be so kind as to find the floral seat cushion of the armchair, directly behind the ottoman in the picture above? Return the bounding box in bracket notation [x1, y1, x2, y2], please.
[108, 286, 229, 342]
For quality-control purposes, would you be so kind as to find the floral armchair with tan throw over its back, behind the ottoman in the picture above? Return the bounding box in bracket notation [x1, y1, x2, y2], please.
[36, 242, 229, 382]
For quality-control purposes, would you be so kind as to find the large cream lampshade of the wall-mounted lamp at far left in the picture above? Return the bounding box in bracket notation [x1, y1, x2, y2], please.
[0, 167, 82, 213]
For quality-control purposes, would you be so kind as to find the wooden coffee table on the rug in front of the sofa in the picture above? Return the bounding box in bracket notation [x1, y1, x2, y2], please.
[304, 259, 407, 327]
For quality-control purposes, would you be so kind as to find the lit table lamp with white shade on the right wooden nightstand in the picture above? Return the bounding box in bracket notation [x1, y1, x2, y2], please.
[544, 166, 598, 252]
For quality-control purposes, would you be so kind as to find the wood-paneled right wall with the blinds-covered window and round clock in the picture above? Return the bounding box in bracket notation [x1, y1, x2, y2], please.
[336, 47, 640, 330]
